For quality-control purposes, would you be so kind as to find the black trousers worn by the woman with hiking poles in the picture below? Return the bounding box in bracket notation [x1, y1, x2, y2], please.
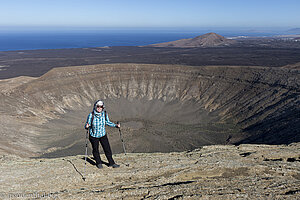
[89, 135, 115, 165]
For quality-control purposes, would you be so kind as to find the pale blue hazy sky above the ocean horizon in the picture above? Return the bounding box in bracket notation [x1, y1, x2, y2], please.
[0, 0, 300, 28]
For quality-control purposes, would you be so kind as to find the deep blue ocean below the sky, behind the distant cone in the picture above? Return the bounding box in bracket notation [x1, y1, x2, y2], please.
[0, 29, 288, 51]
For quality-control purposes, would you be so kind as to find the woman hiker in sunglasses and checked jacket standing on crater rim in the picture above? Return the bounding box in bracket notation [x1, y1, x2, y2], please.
[85, 100, 120, 169]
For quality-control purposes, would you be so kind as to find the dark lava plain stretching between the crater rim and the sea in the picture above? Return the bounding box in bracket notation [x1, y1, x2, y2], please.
[0, 45, 300, 79]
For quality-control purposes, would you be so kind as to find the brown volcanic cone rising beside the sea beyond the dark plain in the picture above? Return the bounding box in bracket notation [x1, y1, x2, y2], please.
[150, 33, 235, 47]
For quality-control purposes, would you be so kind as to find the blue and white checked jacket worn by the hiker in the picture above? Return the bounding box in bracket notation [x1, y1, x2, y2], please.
[85, 110, 116, 138]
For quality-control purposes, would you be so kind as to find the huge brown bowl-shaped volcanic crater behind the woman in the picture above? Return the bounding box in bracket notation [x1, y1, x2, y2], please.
[0, 63, 300, 157]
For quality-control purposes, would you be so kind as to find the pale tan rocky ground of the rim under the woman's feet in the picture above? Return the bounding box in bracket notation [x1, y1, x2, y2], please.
[0, 143, 300, 199]
